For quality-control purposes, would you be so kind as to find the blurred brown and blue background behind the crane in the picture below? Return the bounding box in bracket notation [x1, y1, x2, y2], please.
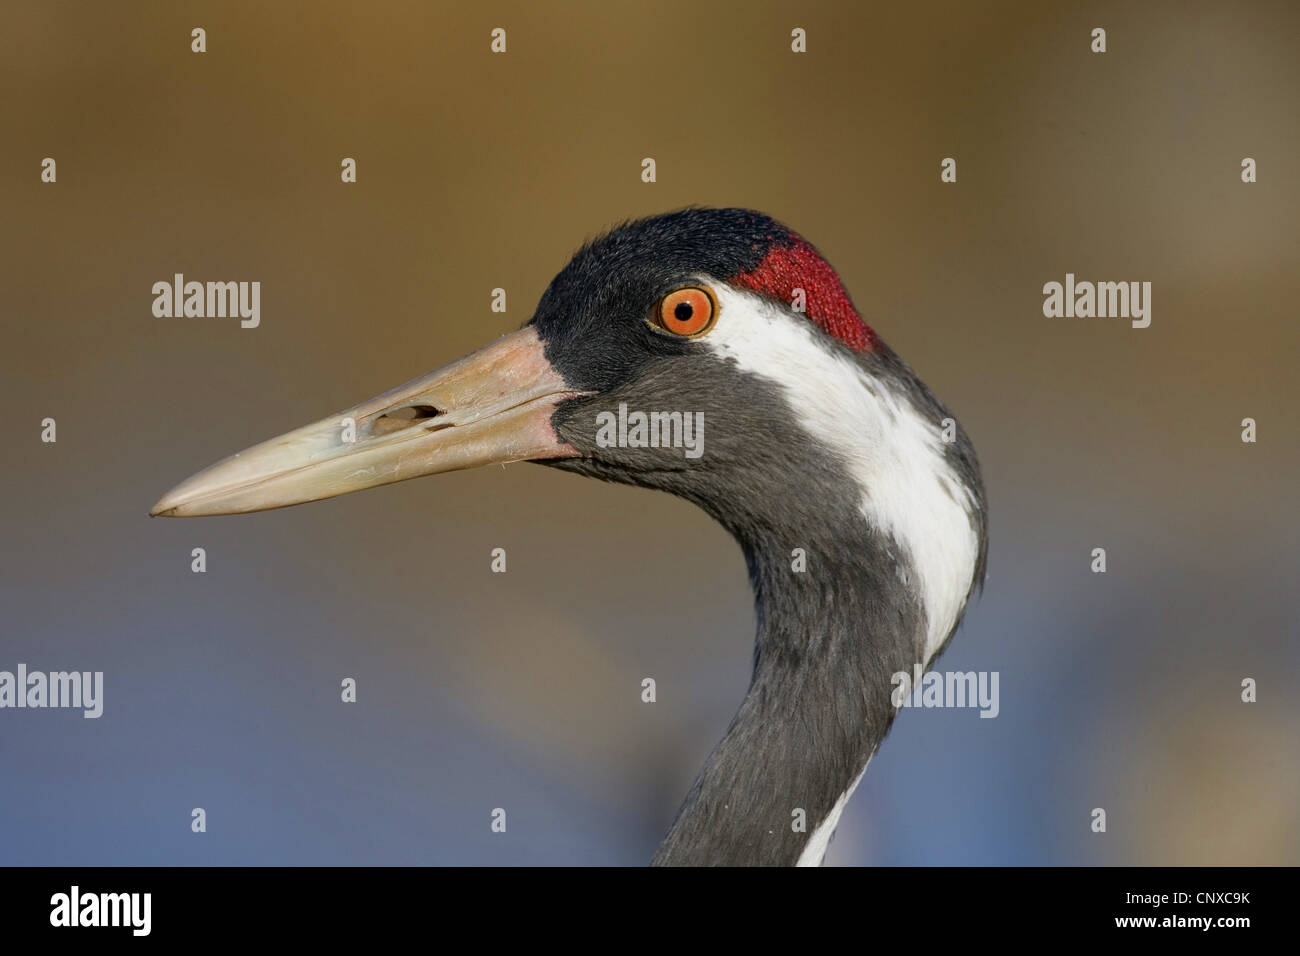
[0, 0, 1300, 864]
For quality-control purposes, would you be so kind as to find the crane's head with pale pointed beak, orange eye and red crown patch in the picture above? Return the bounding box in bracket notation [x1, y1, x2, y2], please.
[152, 208, 984, 650]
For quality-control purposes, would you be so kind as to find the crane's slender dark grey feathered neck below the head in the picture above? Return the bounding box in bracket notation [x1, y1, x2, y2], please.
[654, 515, 926, 866]
